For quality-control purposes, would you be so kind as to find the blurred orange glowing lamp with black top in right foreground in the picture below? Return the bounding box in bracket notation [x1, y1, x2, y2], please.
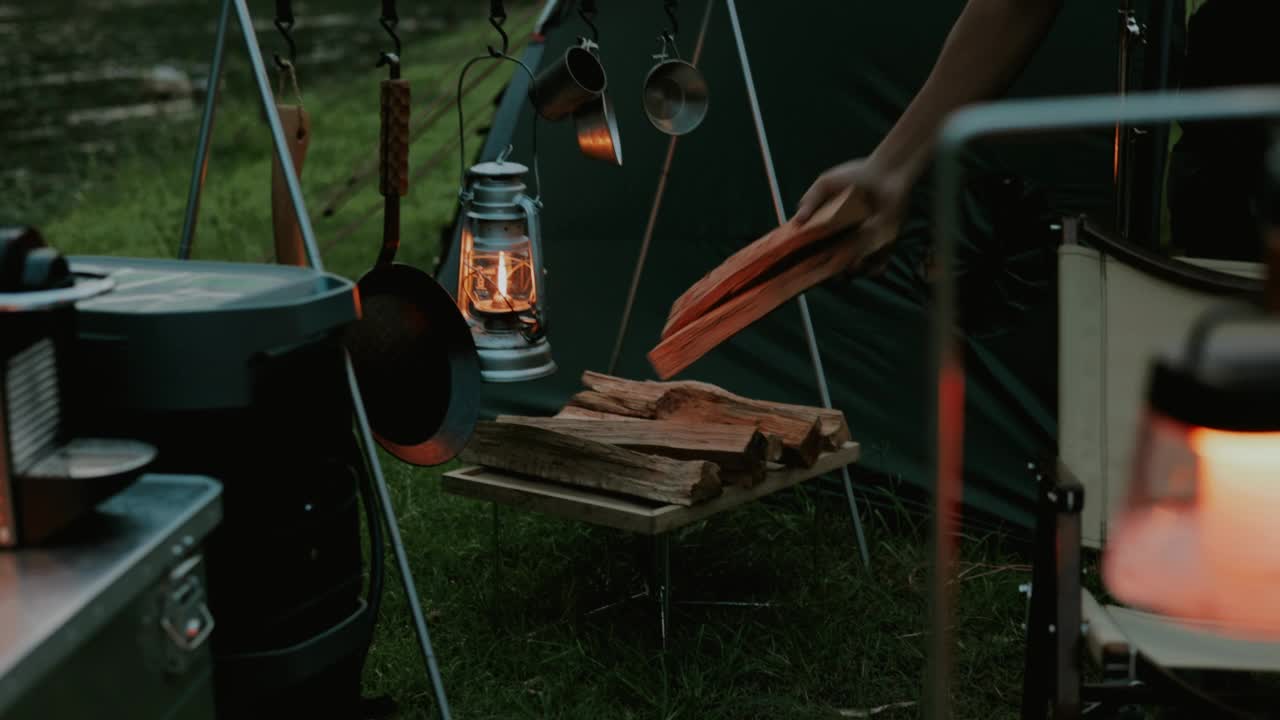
[1103, 304, 1280, 641]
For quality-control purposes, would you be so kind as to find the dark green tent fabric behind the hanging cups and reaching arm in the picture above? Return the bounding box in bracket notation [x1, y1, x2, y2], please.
[439, 0, 1117, 525]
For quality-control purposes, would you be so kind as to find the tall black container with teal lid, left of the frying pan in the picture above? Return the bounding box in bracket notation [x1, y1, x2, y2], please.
[69, 258, 374, 720]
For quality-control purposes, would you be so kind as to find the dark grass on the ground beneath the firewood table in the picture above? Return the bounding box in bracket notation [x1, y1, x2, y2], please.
[366, 462, 1028, 720]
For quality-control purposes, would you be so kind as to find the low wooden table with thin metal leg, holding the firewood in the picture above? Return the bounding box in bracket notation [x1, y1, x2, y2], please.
[442, 442, 861, 646]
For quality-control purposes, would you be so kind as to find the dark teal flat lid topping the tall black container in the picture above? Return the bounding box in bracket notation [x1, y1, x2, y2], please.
[70, 256, 358, 410]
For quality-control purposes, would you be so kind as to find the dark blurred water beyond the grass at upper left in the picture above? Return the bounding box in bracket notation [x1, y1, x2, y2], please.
[0, 0, 488, 205]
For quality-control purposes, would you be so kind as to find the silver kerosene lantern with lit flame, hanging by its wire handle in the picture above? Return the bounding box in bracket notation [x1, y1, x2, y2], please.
[457, 147, 556, 383]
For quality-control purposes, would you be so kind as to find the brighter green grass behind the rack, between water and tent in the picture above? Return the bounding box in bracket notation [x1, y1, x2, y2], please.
[4, 6, 535, 271]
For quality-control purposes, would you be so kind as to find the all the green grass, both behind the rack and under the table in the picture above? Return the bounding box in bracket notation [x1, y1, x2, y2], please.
[6, 11, 1028, 720]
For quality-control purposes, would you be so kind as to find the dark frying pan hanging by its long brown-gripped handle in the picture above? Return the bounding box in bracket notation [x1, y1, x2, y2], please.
[344, 55, 480, 465]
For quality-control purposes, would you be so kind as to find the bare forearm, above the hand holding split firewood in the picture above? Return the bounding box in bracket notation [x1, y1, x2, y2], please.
[873, 0, 1062, 179]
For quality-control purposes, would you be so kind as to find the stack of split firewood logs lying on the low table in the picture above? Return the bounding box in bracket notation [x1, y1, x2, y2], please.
[462, 372, 850, 505]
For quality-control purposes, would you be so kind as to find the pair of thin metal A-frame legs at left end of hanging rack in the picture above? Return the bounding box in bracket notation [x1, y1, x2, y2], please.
[183, 0, 451, 720]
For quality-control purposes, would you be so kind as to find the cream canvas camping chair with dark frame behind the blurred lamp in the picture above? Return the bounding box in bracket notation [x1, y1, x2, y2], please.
[1023, 218, 1280, 719]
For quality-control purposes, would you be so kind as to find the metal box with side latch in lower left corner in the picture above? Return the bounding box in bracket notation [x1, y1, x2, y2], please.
[0, 475, 221, 720]
